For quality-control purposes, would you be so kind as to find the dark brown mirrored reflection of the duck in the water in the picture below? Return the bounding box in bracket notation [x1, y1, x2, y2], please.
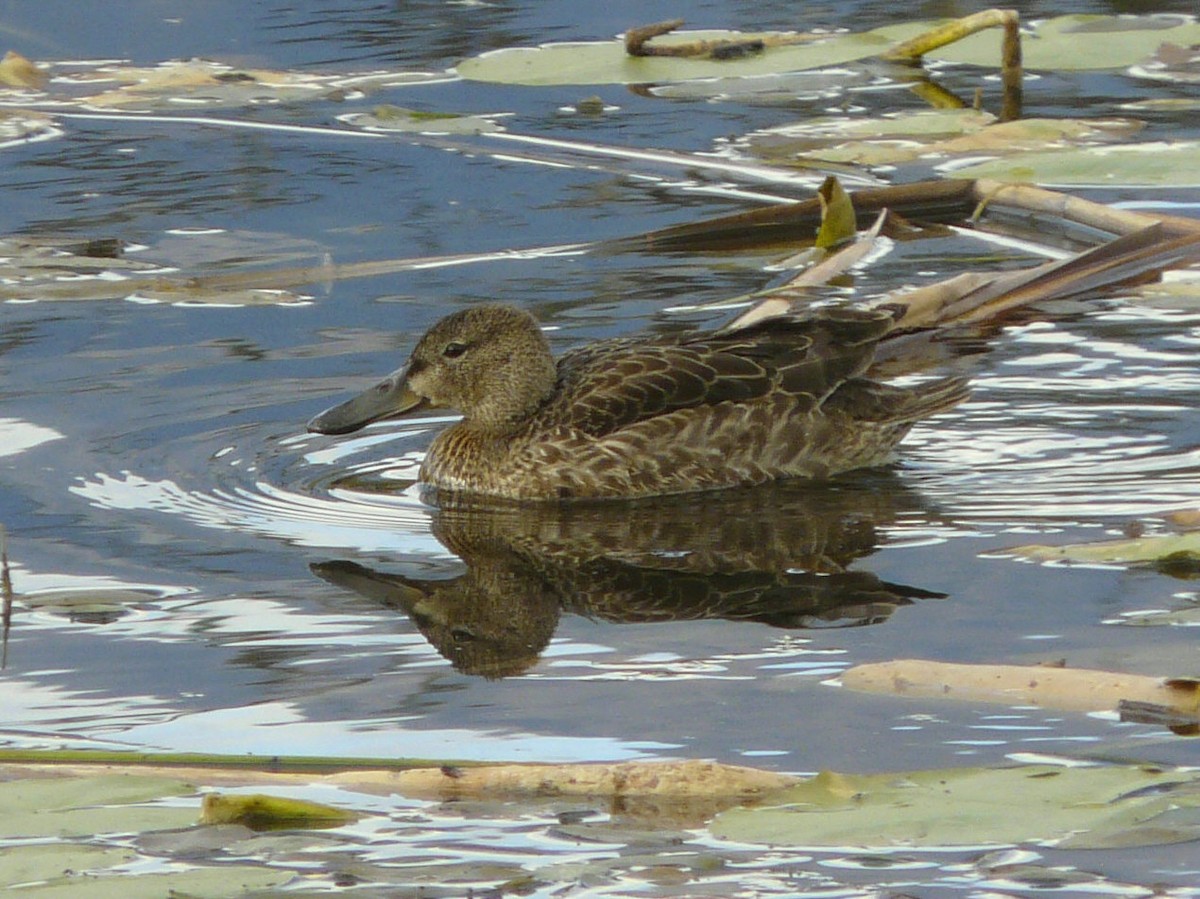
[312, 474, 943, 678]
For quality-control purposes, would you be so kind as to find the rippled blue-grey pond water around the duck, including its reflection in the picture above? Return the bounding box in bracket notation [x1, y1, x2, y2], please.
[0, 0, 1200, 895]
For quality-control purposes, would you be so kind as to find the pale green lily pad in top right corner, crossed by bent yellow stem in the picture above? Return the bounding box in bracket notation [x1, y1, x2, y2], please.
[875, 16, 1200, 72]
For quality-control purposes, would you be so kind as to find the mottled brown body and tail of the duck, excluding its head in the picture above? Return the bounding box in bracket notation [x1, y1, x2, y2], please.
[424, 308, 966, 499]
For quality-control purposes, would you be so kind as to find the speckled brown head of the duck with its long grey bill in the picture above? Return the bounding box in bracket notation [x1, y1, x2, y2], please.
[308, 306, 556, 434]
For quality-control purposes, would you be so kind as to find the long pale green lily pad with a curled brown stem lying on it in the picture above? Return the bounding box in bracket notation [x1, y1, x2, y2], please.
[457, 31, 893, 85]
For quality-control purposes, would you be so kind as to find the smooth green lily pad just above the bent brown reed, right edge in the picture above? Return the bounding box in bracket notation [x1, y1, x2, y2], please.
[947, 140, 1200, 187]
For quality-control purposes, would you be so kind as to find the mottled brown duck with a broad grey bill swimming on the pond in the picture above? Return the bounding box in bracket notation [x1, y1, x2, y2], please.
[307, 304, 968, 502]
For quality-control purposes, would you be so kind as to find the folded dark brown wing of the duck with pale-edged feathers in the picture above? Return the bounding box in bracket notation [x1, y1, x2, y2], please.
[541, 308, 894, 437]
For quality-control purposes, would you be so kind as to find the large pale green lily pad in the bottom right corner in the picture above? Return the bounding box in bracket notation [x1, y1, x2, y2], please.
[710, 765, 1200, 849]
